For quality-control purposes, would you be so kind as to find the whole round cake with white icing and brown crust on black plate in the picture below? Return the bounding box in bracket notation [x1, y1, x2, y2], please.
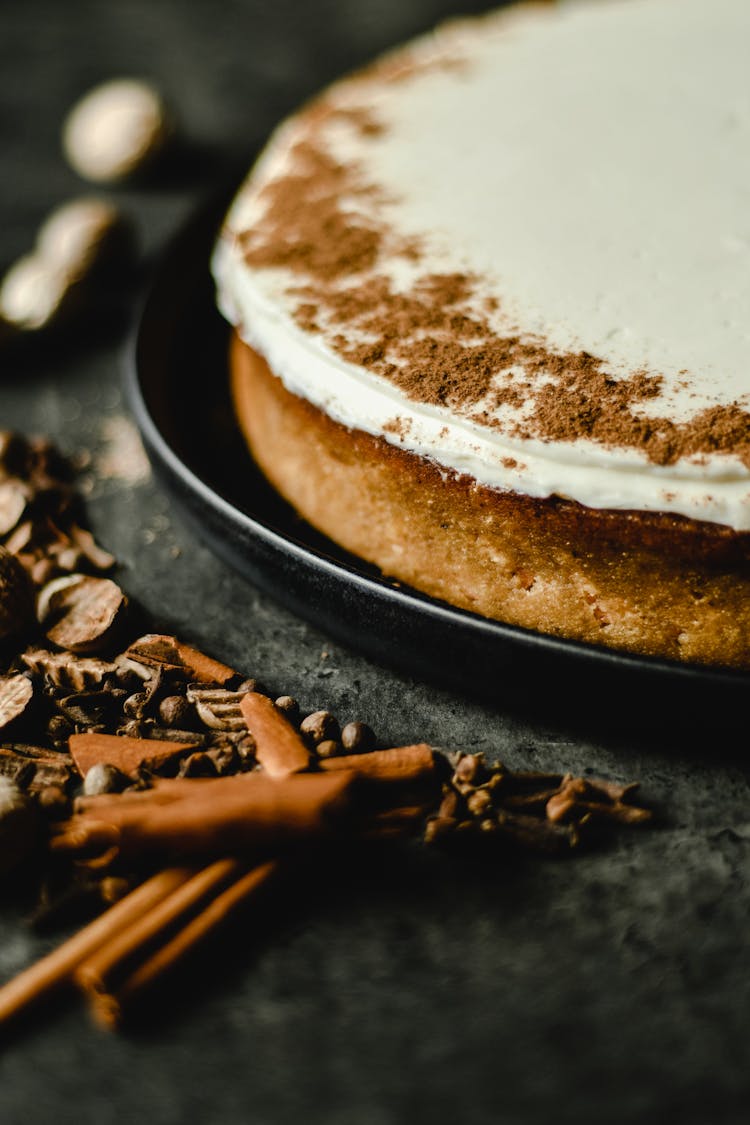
[214, 0, 750, 668]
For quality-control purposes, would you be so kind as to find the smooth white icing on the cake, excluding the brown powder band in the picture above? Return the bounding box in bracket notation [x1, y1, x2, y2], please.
[214, 0, 750, 530]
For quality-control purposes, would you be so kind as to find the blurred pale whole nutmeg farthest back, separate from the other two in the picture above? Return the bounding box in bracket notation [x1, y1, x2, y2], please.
[63, 79, 170, 183]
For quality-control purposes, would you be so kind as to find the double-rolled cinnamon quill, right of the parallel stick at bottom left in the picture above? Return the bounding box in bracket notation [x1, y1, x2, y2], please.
[75, 860, 281, 1028]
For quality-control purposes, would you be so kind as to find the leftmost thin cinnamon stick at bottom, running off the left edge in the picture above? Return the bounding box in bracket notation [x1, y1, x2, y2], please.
[0, 867, 192, 1024]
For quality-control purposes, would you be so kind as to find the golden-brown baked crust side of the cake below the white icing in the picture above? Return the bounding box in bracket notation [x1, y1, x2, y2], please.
[229, 332, 750, 668]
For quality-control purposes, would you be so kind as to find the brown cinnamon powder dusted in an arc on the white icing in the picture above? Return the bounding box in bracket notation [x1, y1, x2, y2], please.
[238, 91, 750, 467]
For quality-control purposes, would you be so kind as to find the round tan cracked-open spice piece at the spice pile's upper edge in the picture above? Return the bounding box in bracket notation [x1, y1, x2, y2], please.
[37, 574, 127, 654]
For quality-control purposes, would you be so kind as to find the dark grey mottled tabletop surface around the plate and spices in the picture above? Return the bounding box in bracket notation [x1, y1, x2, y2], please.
[0, 0, 750, 1125]
